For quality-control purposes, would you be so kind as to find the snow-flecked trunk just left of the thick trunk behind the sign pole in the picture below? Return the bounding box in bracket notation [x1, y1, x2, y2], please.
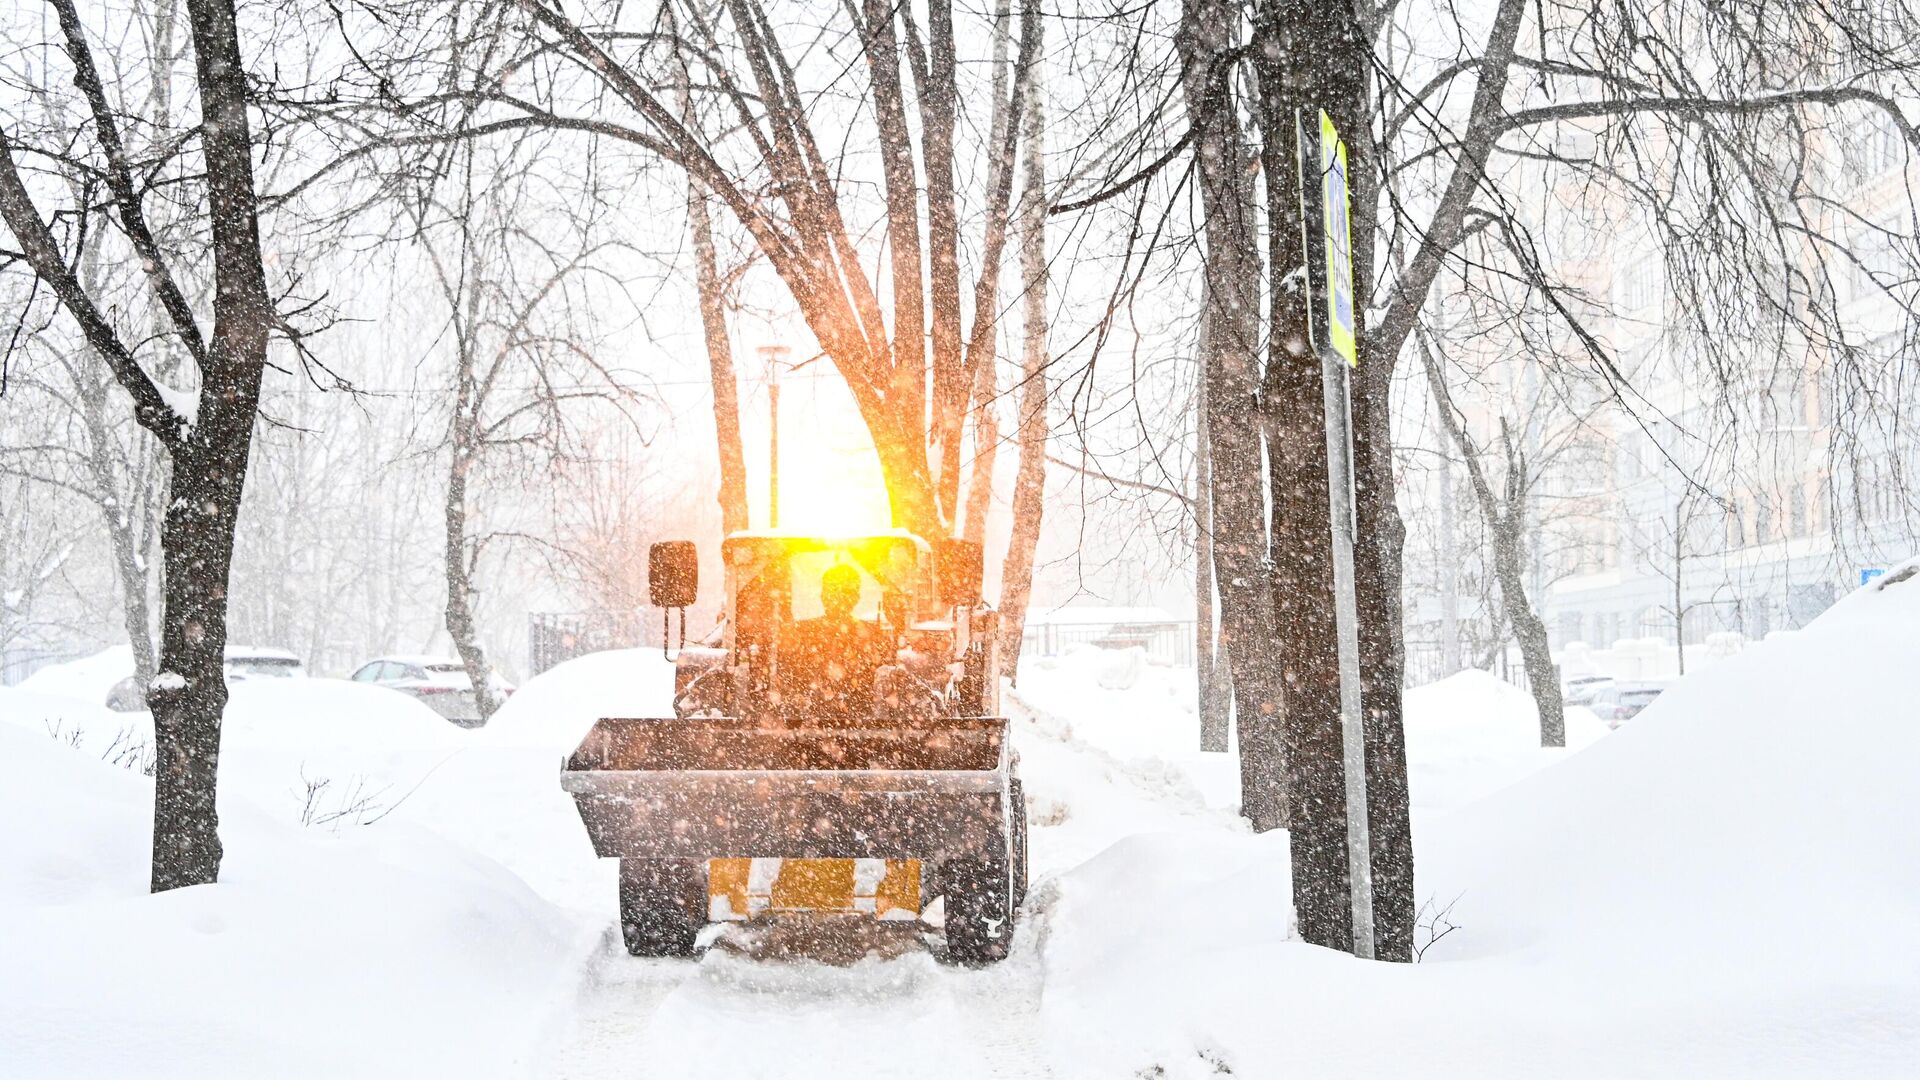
[1177, 0, 1286, 830]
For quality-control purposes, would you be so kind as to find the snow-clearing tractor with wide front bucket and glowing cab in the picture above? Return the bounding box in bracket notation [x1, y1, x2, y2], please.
[561, 532, 1027, 965]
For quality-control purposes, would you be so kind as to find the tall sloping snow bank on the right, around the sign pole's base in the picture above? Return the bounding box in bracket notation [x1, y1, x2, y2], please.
[1043, 578, 1920, 1078]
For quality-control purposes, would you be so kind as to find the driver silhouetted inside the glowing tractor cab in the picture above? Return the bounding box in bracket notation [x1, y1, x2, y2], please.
[780, 563, 887, 719]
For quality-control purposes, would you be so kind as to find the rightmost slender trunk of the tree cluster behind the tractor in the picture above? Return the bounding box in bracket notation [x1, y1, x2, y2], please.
[1000, 0, 1048, 680]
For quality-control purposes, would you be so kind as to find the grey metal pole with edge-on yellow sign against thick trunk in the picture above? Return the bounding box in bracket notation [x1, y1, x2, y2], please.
[1298, 110, 1373, 961]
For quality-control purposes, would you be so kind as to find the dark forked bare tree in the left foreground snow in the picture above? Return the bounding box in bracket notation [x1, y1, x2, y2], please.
[0, 0, 284, 892]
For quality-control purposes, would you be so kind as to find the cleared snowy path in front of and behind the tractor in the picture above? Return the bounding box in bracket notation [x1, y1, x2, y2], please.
[551, 680, 1236, 1080]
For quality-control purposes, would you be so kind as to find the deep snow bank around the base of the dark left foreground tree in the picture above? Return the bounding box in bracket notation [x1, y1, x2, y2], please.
[0, 724, 588, 1078]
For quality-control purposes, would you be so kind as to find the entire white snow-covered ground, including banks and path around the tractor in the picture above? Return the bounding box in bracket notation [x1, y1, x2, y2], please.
[0, 568, 1920, 1078]
